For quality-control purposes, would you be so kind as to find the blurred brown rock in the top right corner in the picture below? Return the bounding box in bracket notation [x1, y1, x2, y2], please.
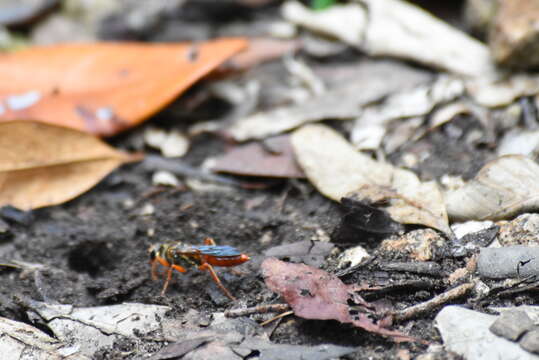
[489, 0, 539, 69]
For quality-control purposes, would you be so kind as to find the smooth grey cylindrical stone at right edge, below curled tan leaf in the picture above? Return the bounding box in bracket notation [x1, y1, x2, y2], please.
[477, 245, 539, 279]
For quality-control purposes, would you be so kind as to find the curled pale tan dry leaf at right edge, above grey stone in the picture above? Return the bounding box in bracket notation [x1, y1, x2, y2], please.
[445, 155, 539, 221]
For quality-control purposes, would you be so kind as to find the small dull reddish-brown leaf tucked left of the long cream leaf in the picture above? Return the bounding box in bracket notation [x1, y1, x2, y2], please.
[210, 135, 305, 178]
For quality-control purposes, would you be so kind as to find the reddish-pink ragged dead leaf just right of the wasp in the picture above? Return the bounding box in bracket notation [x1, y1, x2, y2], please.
[262, 258, 414, 342]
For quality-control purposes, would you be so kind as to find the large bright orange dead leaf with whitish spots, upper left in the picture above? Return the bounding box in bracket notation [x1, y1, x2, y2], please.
[0, 39, 246, 135]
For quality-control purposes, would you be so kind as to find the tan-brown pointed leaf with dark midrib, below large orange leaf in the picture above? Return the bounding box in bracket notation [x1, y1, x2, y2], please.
[0, 121, 137, 210]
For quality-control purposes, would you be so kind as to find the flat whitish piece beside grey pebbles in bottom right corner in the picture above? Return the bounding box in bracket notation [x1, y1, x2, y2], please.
[435, 305, 537, 360]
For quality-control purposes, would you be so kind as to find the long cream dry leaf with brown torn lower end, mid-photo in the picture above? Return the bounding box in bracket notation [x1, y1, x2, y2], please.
[292, 125, 452, 236]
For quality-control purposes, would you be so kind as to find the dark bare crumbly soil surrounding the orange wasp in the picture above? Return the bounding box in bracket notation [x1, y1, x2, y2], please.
[0, 121, 498, 359]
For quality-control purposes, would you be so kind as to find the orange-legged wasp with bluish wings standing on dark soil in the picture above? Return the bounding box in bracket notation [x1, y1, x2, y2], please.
[148, 238, 250, 301]
